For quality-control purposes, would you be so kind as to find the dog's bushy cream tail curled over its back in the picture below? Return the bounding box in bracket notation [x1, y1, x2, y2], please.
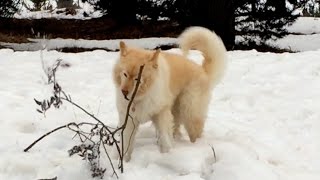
[178, 26, 227, 86]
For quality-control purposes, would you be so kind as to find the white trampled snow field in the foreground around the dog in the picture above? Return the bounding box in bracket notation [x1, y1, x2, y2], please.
[0, 45, 320, 180]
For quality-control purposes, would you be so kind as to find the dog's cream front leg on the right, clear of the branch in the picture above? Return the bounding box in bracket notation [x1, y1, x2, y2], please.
[153, 108, 173, 153]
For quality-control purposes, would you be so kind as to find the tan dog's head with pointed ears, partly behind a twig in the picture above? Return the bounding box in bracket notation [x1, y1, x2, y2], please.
[113, 41, 160, 99]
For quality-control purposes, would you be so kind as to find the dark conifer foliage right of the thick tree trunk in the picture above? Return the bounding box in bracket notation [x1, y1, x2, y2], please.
[234, 0, 297, 44]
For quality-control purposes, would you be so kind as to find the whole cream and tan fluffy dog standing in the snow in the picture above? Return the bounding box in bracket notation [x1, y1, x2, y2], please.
[113, 27, 227, 161]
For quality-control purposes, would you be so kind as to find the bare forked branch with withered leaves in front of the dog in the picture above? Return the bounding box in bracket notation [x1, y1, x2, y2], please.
[24, 57, 144, 178]
